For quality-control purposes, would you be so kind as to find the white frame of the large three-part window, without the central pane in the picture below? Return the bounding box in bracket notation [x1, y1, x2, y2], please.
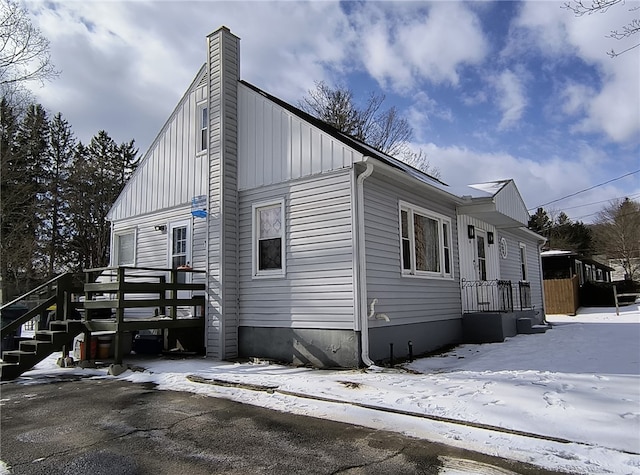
[398, 201, 454, 280]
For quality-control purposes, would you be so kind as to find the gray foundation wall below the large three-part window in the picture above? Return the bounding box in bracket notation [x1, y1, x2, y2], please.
[369, 319, 462, 362]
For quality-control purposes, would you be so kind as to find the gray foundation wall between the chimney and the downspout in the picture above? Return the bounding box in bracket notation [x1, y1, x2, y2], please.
[239, 326, 360, 368]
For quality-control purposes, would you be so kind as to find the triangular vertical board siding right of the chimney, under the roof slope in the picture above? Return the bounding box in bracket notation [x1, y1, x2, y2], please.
[238, 84, 362, 190]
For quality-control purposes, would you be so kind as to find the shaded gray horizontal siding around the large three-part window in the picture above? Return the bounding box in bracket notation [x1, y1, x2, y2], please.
[364, 172, 462, 327]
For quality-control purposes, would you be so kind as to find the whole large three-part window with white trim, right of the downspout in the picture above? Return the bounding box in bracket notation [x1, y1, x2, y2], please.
[400, 202, 453, 278]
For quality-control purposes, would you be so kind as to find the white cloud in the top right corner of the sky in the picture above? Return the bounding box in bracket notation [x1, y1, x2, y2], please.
[503, 1, 640, 142]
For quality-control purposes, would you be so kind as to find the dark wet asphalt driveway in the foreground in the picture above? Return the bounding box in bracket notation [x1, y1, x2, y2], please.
[0, 378, 568, 475]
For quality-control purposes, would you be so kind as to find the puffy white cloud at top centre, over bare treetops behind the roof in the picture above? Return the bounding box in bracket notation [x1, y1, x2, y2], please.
[353, 2, 488, 92]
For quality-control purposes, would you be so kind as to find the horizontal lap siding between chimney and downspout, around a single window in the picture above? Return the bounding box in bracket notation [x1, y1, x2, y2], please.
[239, 171, 354, 329]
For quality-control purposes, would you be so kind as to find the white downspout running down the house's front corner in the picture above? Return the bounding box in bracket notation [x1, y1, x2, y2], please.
[356, 162, 375, 366]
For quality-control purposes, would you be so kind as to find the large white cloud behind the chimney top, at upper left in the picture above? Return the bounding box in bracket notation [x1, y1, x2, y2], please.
[27, 1, 353, 151]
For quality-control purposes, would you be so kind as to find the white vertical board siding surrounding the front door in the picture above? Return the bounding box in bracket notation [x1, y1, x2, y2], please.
[458, 214, 503, 280]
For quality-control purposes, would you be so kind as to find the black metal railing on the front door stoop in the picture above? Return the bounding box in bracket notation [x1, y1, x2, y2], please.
[460, 279, 533, 313]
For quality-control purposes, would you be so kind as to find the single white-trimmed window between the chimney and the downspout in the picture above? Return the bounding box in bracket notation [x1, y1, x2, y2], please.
[253, 200, 285, 277]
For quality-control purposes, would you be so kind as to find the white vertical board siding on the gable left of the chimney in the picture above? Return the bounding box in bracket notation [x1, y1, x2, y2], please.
[109, 70, 207, 221]
